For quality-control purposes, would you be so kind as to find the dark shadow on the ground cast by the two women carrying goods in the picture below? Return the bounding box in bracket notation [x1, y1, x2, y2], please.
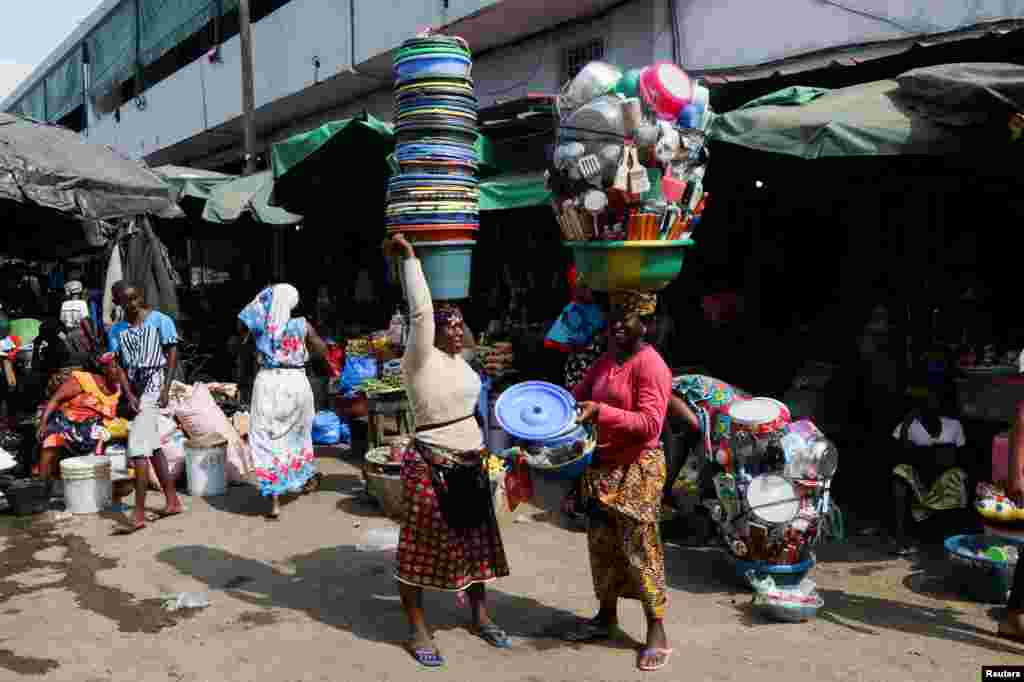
[158, 545, 639, 651]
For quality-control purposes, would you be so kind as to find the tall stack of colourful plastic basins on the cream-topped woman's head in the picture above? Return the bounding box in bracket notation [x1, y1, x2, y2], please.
[387, 36, 480, 300]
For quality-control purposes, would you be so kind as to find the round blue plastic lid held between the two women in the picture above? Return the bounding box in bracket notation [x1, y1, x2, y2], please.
[495, 381, 577, 441]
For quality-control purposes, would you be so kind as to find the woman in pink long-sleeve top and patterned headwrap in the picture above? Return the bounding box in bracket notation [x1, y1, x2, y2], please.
[567, 292, 672, 671]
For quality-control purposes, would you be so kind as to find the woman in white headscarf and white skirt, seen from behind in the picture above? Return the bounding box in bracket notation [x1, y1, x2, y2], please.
[239, 284, 327, 519]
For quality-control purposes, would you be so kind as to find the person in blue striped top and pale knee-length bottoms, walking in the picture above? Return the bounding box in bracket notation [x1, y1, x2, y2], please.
[110, 282, 183, 532]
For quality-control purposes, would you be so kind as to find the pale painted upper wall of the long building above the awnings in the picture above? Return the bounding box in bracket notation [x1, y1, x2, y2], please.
[72, 0, 1024, 158]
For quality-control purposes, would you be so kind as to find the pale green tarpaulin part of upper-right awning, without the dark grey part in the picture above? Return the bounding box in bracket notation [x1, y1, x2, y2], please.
[709, 80, 974, 159]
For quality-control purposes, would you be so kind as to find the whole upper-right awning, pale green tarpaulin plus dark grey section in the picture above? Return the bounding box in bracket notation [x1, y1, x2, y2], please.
[709, 63, 1024, 159]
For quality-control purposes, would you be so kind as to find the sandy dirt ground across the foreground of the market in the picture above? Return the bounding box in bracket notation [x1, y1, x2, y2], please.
[0, 446, 1024, 682]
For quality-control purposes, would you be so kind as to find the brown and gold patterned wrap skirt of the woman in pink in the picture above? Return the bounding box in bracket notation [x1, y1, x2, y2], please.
[583, 449, 668, 619]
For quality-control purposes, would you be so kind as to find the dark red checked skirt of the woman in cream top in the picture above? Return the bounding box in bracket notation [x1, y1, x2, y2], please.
[395, 443, 509, 592]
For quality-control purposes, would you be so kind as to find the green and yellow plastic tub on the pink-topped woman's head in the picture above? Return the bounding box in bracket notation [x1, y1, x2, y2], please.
[566, 239, 693, 291]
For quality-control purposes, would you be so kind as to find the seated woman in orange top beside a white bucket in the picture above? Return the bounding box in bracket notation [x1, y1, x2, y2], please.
[39, 353, 121, 480]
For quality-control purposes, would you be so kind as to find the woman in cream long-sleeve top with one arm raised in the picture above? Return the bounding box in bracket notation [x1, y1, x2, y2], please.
[384, 235, 511, 668]
